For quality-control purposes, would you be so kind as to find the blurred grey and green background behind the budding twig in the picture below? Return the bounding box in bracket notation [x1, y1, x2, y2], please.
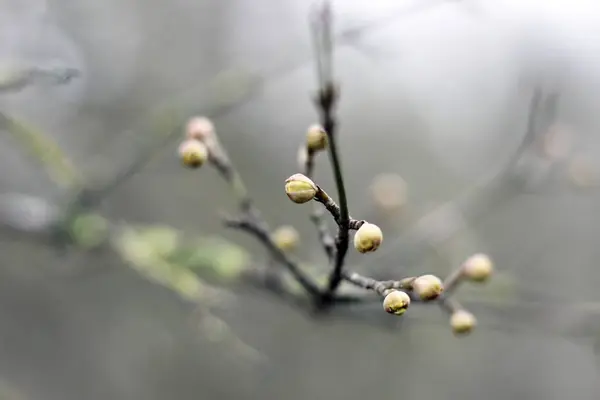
[0, 0, 600, 400]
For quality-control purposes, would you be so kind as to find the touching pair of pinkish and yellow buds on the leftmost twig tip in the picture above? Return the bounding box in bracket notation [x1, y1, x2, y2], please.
[178, 117, 215, 169]
